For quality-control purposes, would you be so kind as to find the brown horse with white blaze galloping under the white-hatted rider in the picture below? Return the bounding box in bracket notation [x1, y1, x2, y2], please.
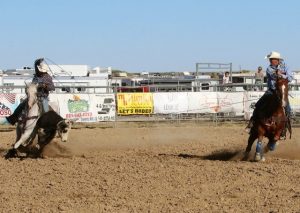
[244, 77, 292, 161]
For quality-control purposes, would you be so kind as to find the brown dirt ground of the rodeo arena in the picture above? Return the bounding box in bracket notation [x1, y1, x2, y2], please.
[0, 123, 300, 213]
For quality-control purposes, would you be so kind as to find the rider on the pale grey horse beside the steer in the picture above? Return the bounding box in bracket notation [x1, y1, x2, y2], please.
[0, 58, 55, 125]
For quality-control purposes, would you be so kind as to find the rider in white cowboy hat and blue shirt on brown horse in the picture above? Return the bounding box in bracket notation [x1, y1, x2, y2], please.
[246, 51, 293, 137]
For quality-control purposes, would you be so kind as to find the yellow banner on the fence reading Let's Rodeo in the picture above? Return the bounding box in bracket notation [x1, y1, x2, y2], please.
[117, 93, 153, 115]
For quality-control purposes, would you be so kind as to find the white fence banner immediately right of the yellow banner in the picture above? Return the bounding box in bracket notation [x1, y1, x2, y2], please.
[153, 92, 188, 114]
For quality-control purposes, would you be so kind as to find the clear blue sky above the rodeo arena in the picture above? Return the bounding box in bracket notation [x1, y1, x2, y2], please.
[0, 0, 300, 72]
